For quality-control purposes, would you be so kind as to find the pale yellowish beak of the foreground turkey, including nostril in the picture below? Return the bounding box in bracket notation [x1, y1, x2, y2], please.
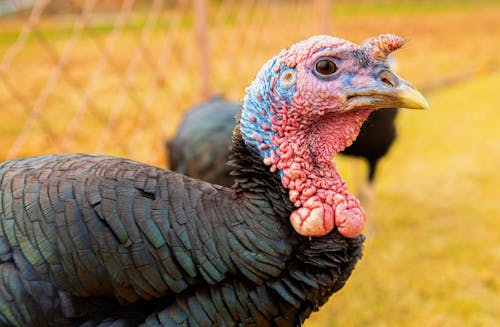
[347, 70, 429, 110]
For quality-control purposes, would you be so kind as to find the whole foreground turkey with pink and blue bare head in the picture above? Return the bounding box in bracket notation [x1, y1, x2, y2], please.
[0, 34, 428, 326]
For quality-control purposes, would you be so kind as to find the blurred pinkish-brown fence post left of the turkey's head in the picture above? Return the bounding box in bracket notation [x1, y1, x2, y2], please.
[194, 0, 211, 98]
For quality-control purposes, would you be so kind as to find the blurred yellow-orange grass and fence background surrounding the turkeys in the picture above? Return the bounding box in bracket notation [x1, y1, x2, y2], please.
[0, 0, 500, 326]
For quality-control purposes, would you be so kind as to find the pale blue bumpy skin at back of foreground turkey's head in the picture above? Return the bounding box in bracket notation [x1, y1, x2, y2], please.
[240, 56, 297, 177]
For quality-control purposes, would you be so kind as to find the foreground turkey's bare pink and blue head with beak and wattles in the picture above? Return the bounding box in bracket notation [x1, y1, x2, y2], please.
[241, 34, 427, 237]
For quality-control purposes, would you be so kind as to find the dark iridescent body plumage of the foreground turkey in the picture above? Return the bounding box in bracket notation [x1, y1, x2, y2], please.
[0, 133, 361, 326]
